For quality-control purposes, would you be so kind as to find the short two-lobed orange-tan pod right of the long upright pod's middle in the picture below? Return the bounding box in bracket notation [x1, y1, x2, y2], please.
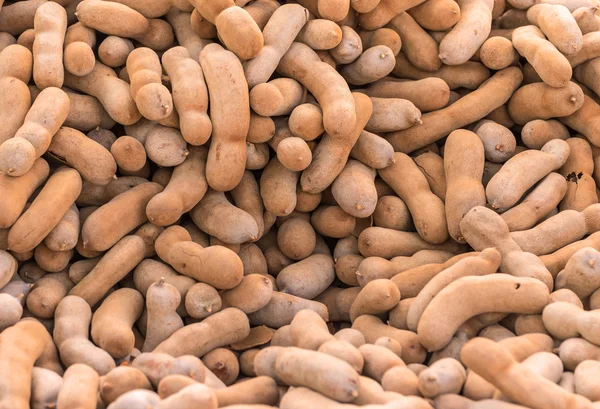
[250, 78, 304, 116]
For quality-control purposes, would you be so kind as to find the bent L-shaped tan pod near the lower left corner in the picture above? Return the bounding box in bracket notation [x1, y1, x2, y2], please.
[53, 295, 115, 375]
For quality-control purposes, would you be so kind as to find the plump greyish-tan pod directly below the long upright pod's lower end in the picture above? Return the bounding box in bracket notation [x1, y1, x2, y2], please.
[190, 189, 258, 244]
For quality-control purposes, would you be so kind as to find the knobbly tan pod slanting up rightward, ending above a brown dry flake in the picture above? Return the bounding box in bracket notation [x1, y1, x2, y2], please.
[154, 308, 250, 357]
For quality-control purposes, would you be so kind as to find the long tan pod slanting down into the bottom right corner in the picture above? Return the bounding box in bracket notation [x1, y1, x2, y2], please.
[461, 338, 591, 409]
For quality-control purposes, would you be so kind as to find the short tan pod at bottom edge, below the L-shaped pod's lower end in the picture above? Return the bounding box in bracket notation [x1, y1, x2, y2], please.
[99, 366, 152, 405]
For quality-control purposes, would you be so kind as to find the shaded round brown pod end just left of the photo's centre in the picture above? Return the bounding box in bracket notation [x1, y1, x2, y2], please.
[277, 217, 317, 261]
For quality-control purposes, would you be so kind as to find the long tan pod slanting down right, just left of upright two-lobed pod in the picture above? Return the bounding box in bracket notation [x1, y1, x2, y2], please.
[379, 152, 448, 244]
